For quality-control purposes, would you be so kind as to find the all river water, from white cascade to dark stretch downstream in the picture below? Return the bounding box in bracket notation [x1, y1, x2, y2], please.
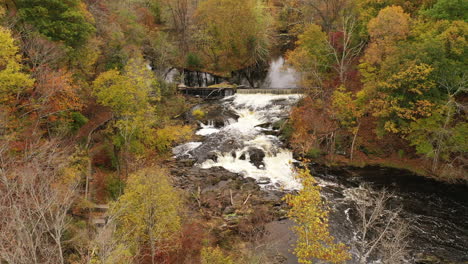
[173, 57, 468, 263]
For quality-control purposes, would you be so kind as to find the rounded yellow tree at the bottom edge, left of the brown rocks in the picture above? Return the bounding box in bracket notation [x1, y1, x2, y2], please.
[111, 168, 182, 263]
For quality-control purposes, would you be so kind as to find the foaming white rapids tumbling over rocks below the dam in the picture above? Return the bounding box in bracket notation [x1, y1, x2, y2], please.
[173, 94, 301, 190]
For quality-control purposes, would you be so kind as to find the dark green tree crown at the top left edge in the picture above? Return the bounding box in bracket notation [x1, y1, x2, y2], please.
[16, 0, 95, 48]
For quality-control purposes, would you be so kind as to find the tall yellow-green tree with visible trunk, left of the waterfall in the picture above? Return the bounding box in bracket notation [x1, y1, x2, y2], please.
[93, 57, 159, 176]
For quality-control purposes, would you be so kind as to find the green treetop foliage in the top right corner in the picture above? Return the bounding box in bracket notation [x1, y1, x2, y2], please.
[421, 0, 468, 22]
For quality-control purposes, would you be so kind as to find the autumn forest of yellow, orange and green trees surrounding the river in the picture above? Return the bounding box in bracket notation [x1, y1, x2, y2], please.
[0, 0, 468, 264]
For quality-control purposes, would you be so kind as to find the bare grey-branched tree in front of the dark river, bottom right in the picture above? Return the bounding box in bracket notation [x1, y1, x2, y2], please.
[353, 187, 409, 264]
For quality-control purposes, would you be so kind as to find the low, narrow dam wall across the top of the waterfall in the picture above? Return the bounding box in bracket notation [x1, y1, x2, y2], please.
[178, 84, 304, 99]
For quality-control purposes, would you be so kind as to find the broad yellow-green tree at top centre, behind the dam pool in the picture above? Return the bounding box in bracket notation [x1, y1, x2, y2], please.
[196, 0, 271, 72]
